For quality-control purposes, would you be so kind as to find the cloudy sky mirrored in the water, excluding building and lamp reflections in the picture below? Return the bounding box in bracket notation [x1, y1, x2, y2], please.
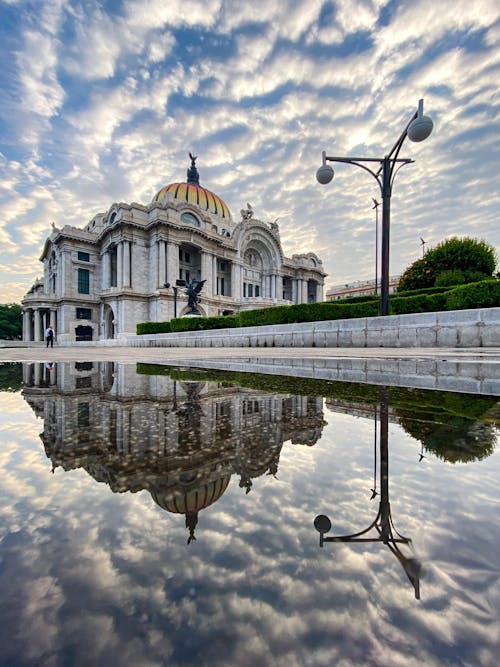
[0, 397, 500, 666]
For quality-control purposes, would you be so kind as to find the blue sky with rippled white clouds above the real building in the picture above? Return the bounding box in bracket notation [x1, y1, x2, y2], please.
[0, 0, 500, 302]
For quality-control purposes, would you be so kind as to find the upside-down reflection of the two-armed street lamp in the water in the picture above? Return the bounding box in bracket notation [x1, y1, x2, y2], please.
[314, 387, 421, 600]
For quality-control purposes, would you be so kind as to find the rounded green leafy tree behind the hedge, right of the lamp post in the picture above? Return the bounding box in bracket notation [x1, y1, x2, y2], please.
[397, 236, 497, 292]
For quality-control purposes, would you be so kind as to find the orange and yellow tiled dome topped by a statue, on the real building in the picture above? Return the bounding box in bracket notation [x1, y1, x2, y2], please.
[153, 153, 231, 220]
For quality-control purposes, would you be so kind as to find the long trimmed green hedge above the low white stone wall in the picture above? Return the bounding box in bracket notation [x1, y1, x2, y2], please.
[137, 280, 500, 334]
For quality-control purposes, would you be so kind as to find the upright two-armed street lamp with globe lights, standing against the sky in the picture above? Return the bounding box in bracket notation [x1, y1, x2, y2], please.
[316, 100, 433, 315]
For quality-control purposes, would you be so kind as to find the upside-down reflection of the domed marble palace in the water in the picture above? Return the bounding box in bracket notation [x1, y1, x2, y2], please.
[23, 362, 325, 540]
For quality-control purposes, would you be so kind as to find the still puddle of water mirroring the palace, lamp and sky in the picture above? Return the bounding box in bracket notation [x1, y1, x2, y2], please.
[0, 362, 500, 666]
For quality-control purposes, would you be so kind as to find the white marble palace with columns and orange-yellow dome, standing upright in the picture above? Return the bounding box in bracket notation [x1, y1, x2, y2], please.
[22, 158, 326, 342]
